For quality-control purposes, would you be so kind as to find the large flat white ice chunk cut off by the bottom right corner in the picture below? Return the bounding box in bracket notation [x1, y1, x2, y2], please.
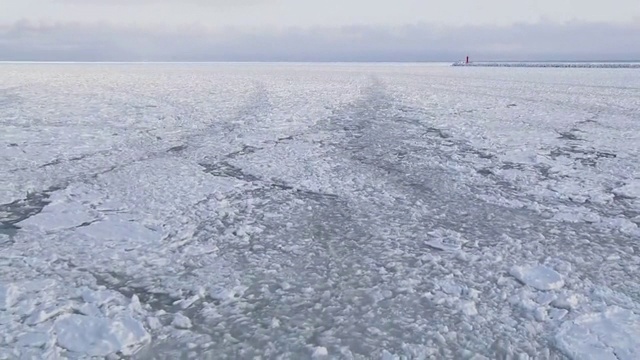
[556, 306, 640, 360]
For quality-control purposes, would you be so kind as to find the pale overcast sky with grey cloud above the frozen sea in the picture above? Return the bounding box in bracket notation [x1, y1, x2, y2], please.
[0, 0, 640, 61]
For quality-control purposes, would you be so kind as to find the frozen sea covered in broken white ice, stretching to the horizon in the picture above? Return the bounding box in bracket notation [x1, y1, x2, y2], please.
[0, 63, 640, 360]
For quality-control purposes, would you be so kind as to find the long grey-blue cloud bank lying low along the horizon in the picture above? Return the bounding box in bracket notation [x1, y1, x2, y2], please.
[0, 21, 640, 61]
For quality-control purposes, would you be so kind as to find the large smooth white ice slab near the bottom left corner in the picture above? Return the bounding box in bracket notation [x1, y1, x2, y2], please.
[54, 314, 150, 356]
